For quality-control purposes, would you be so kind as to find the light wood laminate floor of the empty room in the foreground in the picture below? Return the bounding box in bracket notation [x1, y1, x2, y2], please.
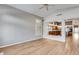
[3, 39, 79, 55]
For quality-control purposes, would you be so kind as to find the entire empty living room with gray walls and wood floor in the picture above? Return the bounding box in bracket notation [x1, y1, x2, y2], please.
[0, 4, 79, 55]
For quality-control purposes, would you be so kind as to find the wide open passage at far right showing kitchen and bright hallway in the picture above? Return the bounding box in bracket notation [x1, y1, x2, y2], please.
[65, 19, 79, 51]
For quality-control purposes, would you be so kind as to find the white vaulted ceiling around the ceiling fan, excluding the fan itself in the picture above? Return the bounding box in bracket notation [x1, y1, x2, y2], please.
[9, 4, 79, 17]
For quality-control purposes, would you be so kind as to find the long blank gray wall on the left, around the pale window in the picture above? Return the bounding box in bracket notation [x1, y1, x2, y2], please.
[0, 5, 42, 46]
